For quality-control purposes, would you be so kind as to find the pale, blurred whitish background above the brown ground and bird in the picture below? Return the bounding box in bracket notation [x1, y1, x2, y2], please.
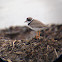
[0, 0, 62, 29]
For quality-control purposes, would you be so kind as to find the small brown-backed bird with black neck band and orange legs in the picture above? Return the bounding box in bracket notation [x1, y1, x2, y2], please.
[25, 17, 46, 39]
